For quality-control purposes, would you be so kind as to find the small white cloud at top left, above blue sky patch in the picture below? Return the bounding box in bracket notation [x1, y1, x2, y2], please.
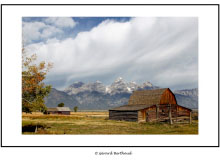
[44, 17, 77, 28]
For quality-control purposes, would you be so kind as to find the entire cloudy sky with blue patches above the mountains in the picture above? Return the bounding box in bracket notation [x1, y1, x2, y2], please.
[22, 17, 198, 90]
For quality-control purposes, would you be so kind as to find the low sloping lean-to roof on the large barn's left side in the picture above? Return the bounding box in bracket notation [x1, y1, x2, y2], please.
[110, 105, 153, 111]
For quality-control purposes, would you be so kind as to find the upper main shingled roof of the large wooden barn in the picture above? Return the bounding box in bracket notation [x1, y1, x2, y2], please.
[128, 88, 168, 105]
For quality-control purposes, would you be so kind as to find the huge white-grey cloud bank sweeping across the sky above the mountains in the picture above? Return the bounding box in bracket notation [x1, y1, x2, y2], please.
[24, 18, 198, 88]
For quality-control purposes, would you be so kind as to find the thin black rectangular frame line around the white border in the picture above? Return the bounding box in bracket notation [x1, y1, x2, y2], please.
[1, 4, 220, 148]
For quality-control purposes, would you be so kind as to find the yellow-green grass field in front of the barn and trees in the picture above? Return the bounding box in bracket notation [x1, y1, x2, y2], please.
[22, 112, 198, 134]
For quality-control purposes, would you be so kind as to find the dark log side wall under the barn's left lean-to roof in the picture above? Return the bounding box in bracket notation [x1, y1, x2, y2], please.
[109, 111, 138, 121]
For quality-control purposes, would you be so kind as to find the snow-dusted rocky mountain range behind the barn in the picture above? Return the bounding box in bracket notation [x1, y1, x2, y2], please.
[45, 77, 198, 110]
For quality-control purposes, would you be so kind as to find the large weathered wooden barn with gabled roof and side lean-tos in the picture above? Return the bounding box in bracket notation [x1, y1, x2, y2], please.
[109, 88, 192, 123]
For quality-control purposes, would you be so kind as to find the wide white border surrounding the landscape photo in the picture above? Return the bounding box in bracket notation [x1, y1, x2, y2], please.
[1, 4, 219, 147]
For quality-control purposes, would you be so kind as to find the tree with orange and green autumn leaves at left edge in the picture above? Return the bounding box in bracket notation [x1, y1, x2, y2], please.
[22, 49, 52, 113]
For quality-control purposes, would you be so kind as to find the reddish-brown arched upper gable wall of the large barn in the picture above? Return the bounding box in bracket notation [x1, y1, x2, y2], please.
[160, 89, 177, 104]
